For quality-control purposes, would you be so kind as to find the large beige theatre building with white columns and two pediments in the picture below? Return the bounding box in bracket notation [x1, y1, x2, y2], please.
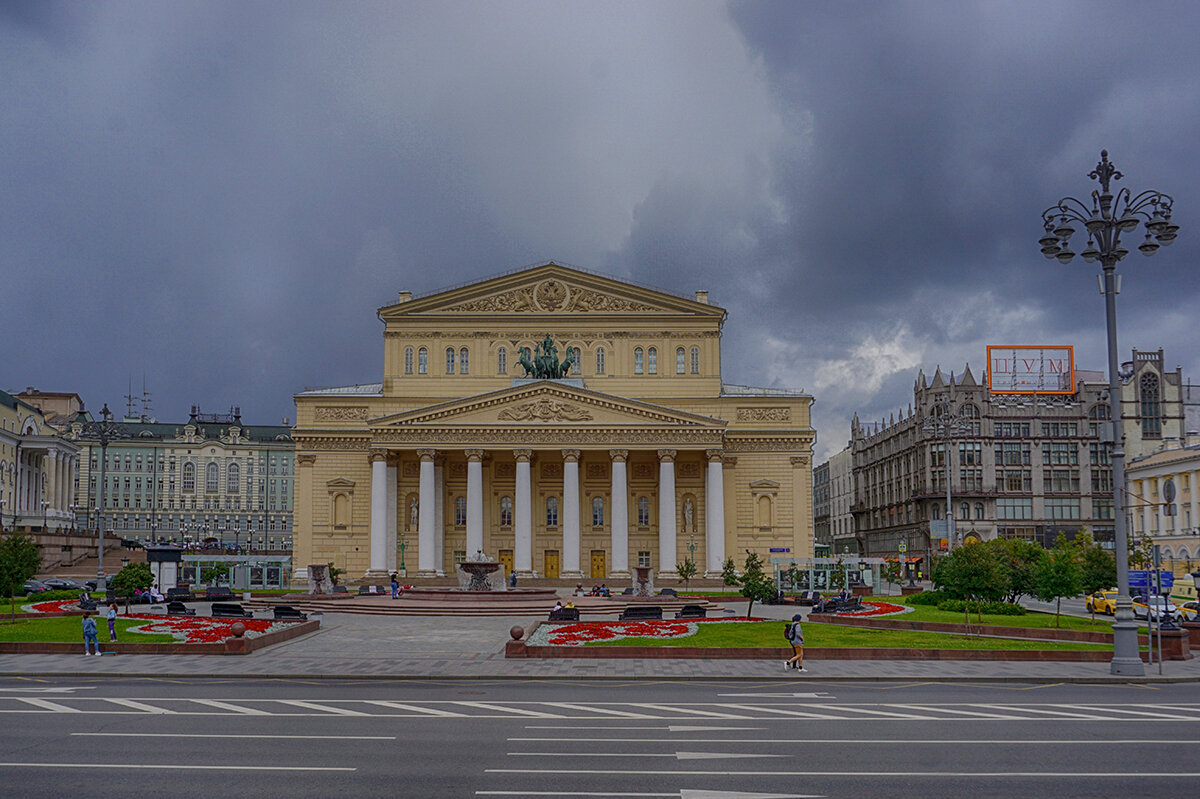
[293, 263, 815, 581]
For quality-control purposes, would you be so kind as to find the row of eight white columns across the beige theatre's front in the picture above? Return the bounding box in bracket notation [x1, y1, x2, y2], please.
[366, 447, 725, 578]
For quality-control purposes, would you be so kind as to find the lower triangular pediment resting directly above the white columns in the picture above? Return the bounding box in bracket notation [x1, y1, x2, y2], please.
[370, 380, 725, 431]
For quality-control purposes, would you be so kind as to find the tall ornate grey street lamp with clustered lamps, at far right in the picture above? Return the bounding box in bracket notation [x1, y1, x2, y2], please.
[1038, 150, 1180, 675]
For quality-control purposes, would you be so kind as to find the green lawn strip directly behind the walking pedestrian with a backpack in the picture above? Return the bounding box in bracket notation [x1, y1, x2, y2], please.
[584, 621, 1112, 650]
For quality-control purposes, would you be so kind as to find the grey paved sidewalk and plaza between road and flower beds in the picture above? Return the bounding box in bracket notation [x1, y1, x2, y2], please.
[0, 605, 1200, 683]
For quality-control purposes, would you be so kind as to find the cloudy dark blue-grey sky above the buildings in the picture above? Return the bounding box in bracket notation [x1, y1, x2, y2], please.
[0, 0, 1200, 461]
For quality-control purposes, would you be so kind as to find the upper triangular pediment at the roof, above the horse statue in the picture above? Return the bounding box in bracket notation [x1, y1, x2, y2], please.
[379, 262, 725, 323]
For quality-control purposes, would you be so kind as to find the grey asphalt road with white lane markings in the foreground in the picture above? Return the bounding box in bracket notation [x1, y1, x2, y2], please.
[0, 667, 1200, 799]
